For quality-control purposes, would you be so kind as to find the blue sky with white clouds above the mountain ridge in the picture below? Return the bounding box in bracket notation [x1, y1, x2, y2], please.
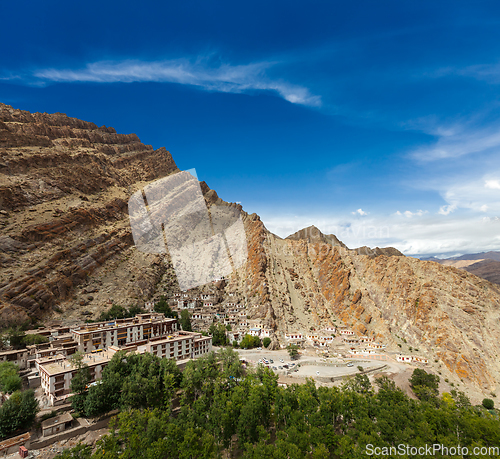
[0, 0, 500, 255]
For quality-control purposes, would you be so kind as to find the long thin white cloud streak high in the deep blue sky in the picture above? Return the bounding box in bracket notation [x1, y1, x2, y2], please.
[17, 59, 321, 107]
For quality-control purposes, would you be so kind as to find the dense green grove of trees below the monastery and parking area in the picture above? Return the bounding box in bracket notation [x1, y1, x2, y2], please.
[59, 354, 500, 459]
